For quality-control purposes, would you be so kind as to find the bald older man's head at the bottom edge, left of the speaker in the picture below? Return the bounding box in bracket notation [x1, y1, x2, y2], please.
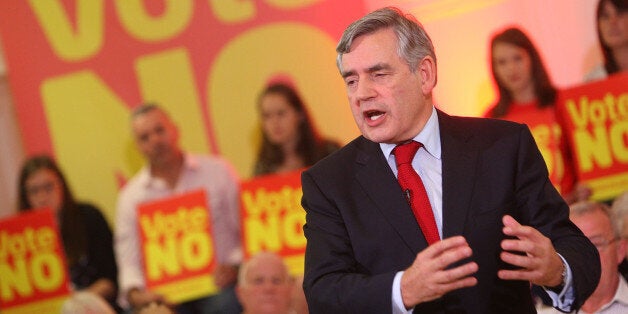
[236, 252, 292, 314]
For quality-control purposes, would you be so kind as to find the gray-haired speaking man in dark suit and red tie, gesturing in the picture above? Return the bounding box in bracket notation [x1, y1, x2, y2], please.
[302, 8, 600, 314]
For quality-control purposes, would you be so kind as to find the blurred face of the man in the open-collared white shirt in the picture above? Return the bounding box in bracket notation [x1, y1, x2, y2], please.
[131, 110, 179, 165]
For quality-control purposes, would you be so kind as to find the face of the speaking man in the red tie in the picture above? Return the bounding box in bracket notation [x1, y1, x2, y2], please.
[341, 29, 435, 143]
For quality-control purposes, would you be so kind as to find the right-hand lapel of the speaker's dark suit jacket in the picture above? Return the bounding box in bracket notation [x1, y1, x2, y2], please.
[438, 111, 478, 238]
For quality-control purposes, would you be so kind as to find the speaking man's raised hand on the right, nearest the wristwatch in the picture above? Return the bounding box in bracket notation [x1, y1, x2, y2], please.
[497, 215, 563, 287]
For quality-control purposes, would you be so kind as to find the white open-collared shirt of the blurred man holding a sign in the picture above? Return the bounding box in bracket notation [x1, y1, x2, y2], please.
[114, 154, 242, 306]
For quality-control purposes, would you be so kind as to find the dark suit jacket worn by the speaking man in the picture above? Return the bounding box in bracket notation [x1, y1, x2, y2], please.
[302, 111, 600, 314]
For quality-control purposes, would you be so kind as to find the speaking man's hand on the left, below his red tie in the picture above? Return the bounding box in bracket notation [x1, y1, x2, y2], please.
[401, 236, 478, 308]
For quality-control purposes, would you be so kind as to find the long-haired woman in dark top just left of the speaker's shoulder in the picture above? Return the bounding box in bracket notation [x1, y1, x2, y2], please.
[254, 83, 340, 176]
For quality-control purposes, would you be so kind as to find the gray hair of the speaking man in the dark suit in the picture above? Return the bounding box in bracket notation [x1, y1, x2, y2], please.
[336, 7, 436, 78]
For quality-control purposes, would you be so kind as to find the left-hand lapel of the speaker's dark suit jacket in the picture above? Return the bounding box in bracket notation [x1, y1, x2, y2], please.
[356, 138, 427, 254]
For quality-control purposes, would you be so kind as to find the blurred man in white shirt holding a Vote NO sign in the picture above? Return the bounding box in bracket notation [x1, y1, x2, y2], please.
[115, 104, 242, 314]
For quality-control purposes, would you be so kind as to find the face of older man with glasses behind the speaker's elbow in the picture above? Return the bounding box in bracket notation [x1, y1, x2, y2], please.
[571, 210, 626, 297]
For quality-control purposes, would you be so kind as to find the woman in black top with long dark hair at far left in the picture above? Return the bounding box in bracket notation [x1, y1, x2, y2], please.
[19, 155, 118, 309]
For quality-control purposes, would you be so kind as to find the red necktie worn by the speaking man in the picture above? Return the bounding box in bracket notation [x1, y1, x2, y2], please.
[393, 141, 440, 244]
